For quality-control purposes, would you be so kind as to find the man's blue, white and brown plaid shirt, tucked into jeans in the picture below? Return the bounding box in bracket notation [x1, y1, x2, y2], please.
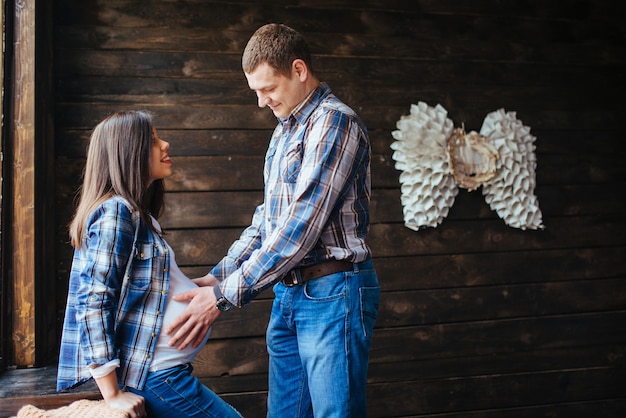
[211, 83, 371, 307]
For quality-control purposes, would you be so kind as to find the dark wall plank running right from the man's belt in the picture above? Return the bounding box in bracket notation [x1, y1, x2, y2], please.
[374, 246, 626, 291]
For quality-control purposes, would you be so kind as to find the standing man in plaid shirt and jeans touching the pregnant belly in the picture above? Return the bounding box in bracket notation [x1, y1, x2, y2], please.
[167, 24, 380, 418]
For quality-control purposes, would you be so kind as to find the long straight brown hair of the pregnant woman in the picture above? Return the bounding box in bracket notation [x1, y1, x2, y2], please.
[69, 111, 165, 248]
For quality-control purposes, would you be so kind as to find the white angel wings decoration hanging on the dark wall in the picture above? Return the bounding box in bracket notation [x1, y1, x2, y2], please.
[391, 102, 544, 231]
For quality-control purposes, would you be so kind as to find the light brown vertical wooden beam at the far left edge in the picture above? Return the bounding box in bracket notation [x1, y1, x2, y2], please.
[11, 0, 35, 367]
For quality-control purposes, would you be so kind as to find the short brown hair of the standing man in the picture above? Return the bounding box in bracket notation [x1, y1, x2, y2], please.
[241, 23, 313, 76]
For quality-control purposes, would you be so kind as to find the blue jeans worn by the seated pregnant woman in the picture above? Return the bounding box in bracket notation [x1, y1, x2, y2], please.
[126, 364, 241, 418]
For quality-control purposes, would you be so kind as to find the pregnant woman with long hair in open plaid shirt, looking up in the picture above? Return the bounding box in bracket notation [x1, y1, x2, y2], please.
[57, 111, 241, 418]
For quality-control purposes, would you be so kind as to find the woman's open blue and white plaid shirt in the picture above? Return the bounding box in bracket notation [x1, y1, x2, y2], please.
[57, 196, 170, 390]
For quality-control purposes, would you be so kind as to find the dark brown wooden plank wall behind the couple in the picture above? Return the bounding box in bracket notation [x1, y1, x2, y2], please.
[50, 0, 626, 418]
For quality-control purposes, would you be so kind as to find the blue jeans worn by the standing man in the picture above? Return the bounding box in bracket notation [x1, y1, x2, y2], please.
[267, 261, 380, 418]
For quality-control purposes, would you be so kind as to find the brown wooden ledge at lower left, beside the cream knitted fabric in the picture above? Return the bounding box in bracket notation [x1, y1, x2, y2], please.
[0, 366, 102, 417]
